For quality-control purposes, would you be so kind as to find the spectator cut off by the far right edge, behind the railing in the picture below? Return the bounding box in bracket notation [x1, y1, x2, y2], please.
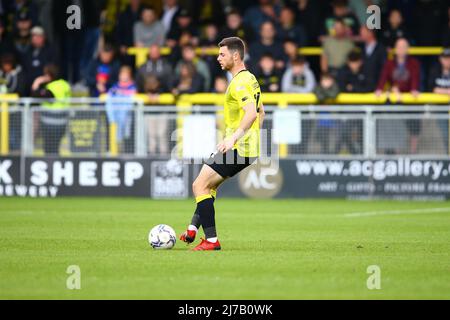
[428, 48, 450, 153]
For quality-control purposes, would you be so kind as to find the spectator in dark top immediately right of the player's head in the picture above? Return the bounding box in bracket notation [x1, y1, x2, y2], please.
[249, 22, 286, 69]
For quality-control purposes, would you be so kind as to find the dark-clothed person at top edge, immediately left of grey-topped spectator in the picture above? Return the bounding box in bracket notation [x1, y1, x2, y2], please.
[116, 0, 142, 65]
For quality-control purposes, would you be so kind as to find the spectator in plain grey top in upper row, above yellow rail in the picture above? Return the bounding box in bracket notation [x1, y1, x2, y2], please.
[133, 7, 166, 47]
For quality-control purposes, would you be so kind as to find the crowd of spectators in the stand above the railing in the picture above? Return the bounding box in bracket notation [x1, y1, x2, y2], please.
[0, 0, 450, 97]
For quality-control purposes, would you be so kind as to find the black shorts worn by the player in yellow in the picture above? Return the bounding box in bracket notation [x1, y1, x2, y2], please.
[205, 150, 257, 178]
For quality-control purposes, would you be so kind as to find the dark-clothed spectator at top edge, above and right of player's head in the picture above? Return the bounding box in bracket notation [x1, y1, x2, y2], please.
[244, 0, 281, 33]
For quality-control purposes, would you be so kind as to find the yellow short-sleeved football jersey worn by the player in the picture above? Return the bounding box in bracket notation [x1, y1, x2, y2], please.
[224, 70, 261, 157]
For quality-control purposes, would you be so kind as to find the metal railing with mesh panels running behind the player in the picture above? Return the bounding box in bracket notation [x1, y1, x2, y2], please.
[0, 98, 450, 159]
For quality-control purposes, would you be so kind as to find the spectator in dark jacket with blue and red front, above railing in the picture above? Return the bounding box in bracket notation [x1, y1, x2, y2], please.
[86, 44, 120, 97]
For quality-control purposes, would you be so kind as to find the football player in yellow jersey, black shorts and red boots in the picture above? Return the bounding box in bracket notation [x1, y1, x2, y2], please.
[180, 37, 264, 251]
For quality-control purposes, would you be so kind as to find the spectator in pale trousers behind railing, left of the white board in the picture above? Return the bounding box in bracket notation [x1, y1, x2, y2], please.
[144, 75, 169, 156]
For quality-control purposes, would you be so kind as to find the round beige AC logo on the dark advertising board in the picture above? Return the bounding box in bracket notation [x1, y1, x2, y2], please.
[239, 163, 283, 198]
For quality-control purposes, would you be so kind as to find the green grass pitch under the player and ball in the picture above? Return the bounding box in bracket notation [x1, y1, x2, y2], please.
[0, 198, 450, 299]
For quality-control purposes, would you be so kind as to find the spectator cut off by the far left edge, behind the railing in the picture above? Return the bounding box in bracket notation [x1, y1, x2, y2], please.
[0, 53, 28, 151]
